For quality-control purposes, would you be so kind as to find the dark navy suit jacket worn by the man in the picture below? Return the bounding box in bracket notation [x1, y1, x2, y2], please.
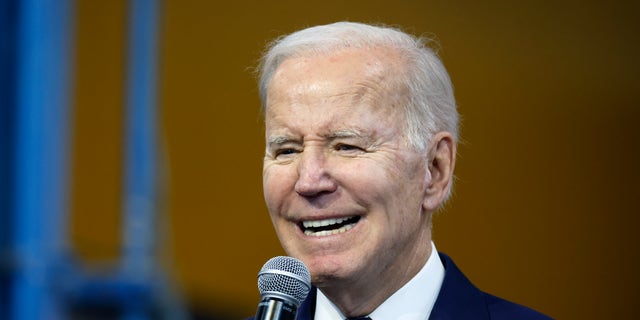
[245, 253, 551, 320]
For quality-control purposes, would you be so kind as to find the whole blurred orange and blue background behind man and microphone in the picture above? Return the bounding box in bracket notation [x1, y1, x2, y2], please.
[0, 0, 640, 320]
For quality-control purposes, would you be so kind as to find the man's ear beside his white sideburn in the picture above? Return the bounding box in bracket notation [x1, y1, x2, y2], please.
[422, 132, 456, 212]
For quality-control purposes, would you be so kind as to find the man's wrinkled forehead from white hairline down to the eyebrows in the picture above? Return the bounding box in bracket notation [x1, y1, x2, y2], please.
[265, 48, 406, 141]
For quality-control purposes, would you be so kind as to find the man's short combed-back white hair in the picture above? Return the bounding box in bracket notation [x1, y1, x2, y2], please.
[259, 22, 458, 150]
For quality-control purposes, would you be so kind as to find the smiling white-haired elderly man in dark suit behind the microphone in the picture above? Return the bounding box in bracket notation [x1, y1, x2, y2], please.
[250, 22, 548, 320]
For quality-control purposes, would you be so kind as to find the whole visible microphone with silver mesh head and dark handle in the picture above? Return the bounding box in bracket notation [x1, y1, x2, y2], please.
[255, 256, 311, 320]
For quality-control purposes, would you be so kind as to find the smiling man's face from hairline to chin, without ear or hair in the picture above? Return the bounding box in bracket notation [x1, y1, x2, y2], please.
[263, 48, 431, 288]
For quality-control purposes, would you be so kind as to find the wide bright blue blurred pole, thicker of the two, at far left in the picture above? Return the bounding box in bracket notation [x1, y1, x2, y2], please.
[10, 0, 73, 320]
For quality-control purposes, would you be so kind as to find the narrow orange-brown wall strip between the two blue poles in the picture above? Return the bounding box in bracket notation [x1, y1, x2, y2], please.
[70, 1, 126, 261]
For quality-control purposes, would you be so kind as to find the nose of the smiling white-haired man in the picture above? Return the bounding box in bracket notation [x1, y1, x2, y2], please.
[295, 148, 337, 197]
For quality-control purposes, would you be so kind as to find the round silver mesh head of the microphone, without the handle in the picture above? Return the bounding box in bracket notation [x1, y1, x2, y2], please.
[258, 256, 311, 307]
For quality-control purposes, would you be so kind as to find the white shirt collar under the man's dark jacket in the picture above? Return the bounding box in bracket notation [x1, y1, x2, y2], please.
[314, 242, 445, 320]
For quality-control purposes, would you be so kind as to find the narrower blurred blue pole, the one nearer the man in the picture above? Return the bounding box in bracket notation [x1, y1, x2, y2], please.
[122, 0, 159, 320]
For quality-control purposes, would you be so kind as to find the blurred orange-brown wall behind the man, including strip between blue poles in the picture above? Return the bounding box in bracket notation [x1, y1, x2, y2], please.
[72, 0, 640, 319]
